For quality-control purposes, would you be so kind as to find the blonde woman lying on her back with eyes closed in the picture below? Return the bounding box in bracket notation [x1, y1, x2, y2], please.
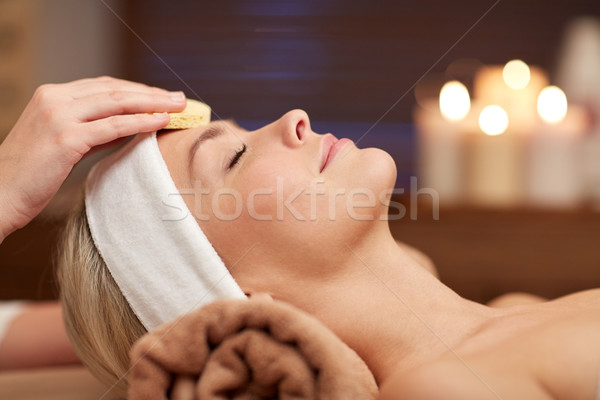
[2, 79, 600, 399]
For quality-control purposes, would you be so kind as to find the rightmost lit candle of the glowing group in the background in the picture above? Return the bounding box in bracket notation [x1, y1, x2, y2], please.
[527, 86, 587, 207]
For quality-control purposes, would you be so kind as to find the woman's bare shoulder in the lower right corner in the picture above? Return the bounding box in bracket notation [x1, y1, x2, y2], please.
[380, 290, 600, 400]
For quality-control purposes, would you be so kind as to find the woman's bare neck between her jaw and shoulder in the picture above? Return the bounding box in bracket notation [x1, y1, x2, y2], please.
[311, 225, 494, 383]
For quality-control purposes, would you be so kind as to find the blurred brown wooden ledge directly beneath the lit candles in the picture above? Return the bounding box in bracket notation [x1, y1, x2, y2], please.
[391, 206, 600, 301]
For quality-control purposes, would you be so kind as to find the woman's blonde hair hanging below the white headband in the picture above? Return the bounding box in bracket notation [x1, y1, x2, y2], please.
[56, 201, 146, 394]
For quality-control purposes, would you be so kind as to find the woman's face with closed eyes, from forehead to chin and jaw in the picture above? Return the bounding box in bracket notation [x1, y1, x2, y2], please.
[158, 110, 396, 297]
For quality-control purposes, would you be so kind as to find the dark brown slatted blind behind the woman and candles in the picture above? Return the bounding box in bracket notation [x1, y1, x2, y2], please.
[123, 0, 600, 122]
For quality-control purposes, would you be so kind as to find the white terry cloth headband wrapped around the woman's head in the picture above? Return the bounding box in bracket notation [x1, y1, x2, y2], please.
[85, 132, 245, 330]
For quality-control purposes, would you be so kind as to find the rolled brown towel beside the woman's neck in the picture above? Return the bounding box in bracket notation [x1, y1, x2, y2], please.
[129, 300, 377, 400]
